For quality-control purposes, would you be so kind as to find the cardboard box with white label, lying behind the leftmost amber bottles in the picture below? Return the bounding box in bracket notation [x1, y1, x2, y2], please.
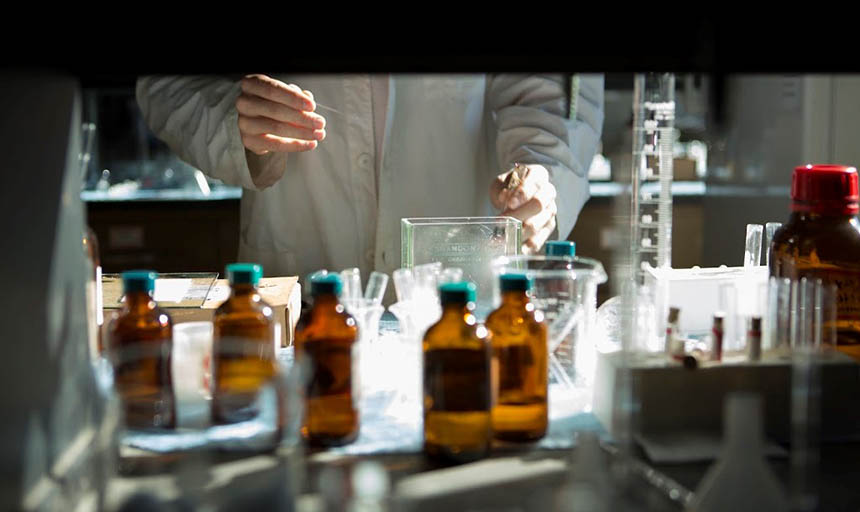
[102, 273, 302, 347]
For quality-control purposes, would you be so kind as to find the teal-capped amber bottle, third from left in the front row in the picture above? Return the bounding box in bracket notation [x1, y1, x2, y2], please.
[296, 274, 359, 446]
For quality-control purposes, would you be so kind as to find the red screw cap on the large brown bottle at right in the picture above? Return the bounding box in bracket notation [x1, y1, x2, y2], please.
[791, 165, 860, 215]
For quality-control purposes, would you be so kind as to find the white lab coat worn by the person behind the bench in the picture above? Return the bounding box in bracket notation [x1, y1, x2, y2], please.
[137, 75, 603, 286]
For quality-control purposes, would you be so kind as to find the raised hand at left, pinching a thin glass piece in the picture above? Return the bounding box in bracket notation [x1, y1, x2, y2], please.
[236, 75, 325, 155]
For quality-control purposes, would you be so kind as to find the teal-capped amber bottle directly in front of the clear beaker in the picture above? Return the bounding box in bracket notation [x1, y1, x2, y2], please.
[486, 274, 549, 441]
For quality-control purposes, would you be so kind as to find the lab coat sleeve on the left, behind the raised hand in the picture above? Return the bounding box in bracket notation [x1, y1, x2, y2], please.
[136, 76, 286, 190]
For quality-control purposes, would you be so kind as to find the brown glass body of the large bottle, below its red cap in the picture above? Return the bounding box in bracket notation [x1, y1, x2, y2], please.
[770, 212, 860, 359]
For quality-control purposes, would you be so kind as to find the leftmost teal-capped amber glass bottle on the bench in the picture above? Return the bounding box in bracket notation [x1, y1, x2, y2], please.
[109, 270, 176, 429]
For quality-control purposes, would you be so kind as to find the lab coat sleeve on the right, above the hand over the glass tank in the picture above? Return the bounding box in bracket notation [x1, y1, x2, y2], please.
[487, 75, 603, 239]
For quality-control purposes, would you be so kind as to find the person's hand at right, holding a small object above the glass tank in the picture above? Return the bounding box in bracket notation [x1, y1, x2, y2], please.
[490, 164, 558, 254]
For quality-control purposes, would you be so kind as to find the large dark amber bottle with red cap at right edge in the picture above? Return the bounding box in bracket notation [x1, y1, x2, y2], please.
[770, 165, 860, 359]
